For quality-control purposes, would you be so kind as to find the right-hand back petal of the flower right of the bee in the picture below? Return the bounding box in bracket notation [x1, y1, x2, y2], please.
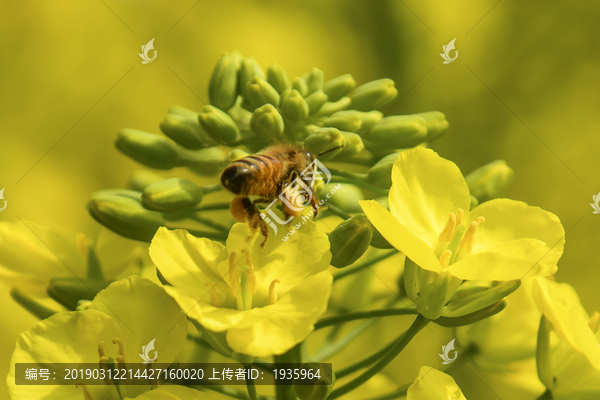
[470, 199, 565, 268]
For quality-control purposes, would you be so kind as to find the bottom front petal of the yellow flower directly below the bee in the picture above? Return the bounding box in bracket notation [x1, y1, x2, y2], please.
[227, 271, 333, 357]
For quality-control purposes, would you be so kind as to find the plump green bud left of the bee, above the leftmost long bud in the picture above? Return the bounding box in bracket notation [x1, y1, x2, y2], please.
[142, 178, 203, 212]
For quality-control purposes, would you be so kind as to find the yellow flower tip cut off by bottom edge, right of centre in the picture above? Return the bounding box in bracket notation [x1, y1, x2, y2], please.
[406, 366, 467, 400]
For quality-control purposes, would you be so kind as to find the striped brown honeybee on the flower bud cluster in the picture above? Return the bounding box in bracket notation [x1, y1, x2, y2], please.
[221, 143, 341, 248]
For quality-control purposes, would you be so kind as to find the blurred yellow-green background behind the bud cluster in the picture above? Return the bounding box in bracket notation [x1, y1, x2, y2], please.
[0, 0, 600, 399]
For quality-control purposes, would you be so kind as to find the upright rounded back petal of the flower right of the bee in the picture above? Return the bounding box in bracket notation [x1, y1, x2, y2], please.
[389, 147, 471, 250]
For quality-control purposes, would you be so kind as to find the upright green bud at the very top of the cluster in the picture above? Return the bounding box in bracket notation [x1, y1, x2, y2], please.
[208, 53, 240, 111]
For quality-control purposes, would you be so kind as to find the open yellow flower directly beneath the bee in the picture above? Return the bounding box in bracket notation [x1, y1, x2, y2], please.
[150, 221, 332, 357]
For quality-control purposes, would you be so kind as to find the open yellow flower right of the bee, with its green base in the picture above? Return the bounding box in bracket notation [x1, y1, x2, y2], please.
[360, 147, 564, 319]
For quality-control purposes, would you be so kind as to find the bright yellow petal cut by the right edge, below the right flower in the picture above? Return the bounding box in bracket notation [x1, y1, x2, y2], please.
[533, 278, 600, 371]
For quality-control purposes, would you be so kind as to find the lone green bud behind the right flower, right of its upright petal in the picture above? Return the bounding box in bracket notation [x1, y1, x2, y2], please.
[465, 160, 513, 203]
